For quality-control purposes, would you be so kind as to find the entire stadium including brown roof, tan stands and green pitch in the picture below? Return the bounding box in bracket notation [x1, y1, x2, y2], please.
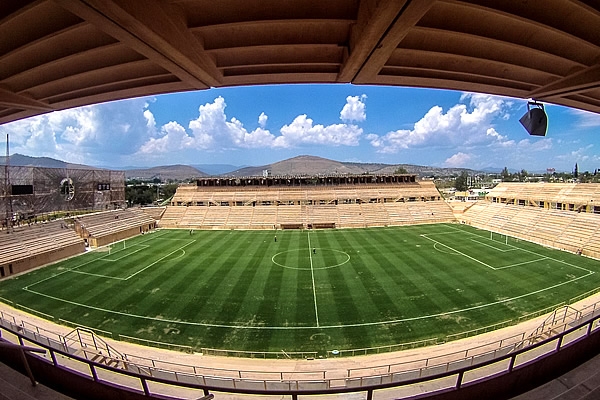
[0, 0, 600, 400]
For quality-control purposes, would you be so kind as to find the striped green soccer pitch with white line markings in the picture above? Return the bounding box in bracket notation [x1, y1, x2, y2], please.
[0, 224, 600, 352]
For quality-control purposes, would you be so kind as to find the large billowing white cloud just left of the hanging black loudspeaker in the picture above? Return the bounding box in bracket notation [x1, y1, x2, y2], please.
[367, 94, 511, 153]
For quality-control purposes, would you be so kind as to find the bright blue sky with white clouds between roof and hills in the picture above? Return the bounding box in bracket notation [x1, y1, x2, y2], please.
[0, 85, 600, 171]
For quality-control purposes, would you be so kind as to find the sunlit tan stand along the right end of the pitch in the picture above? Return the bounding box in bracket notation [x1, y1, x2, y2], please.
[462, 182, 600, 258]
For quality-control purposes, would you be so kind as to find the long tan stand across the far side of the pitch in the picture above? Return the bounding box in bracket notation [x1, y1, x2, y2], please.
[159, 176, 456, 229]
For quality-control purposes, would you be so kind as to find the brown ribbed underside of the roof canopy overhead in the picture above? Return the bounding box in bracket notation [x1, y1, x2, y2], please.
[0, 0, 600, 123]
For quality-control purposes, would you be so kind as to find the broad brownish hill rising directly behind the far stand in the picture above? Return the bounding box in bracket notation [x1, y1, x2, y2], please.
[226, 155, 480, 177]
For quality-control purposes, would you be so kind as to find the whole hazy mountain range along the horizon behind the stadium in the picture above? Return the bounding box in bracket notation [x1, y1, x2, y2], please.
[0, 154, 482, 181]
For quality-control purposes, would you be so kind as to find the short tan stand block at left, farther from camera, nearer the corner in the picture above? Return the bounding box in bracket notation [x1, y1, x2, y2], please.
[75, 209, 156, 247]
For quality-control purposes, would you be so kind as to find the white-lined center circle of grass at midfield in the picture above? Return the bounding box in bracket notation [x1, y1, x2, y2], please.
[271, 247, 350, 271]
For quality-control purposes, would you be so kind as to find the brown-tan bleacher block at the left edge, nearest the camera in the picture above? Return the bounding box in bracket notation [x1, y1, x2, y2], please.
[0, 221, 85, 278]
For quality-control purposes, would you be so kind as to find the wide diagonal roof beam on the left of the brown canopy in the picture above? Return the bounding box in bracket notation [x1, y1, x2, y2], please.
[55, 0, 222, 89]
